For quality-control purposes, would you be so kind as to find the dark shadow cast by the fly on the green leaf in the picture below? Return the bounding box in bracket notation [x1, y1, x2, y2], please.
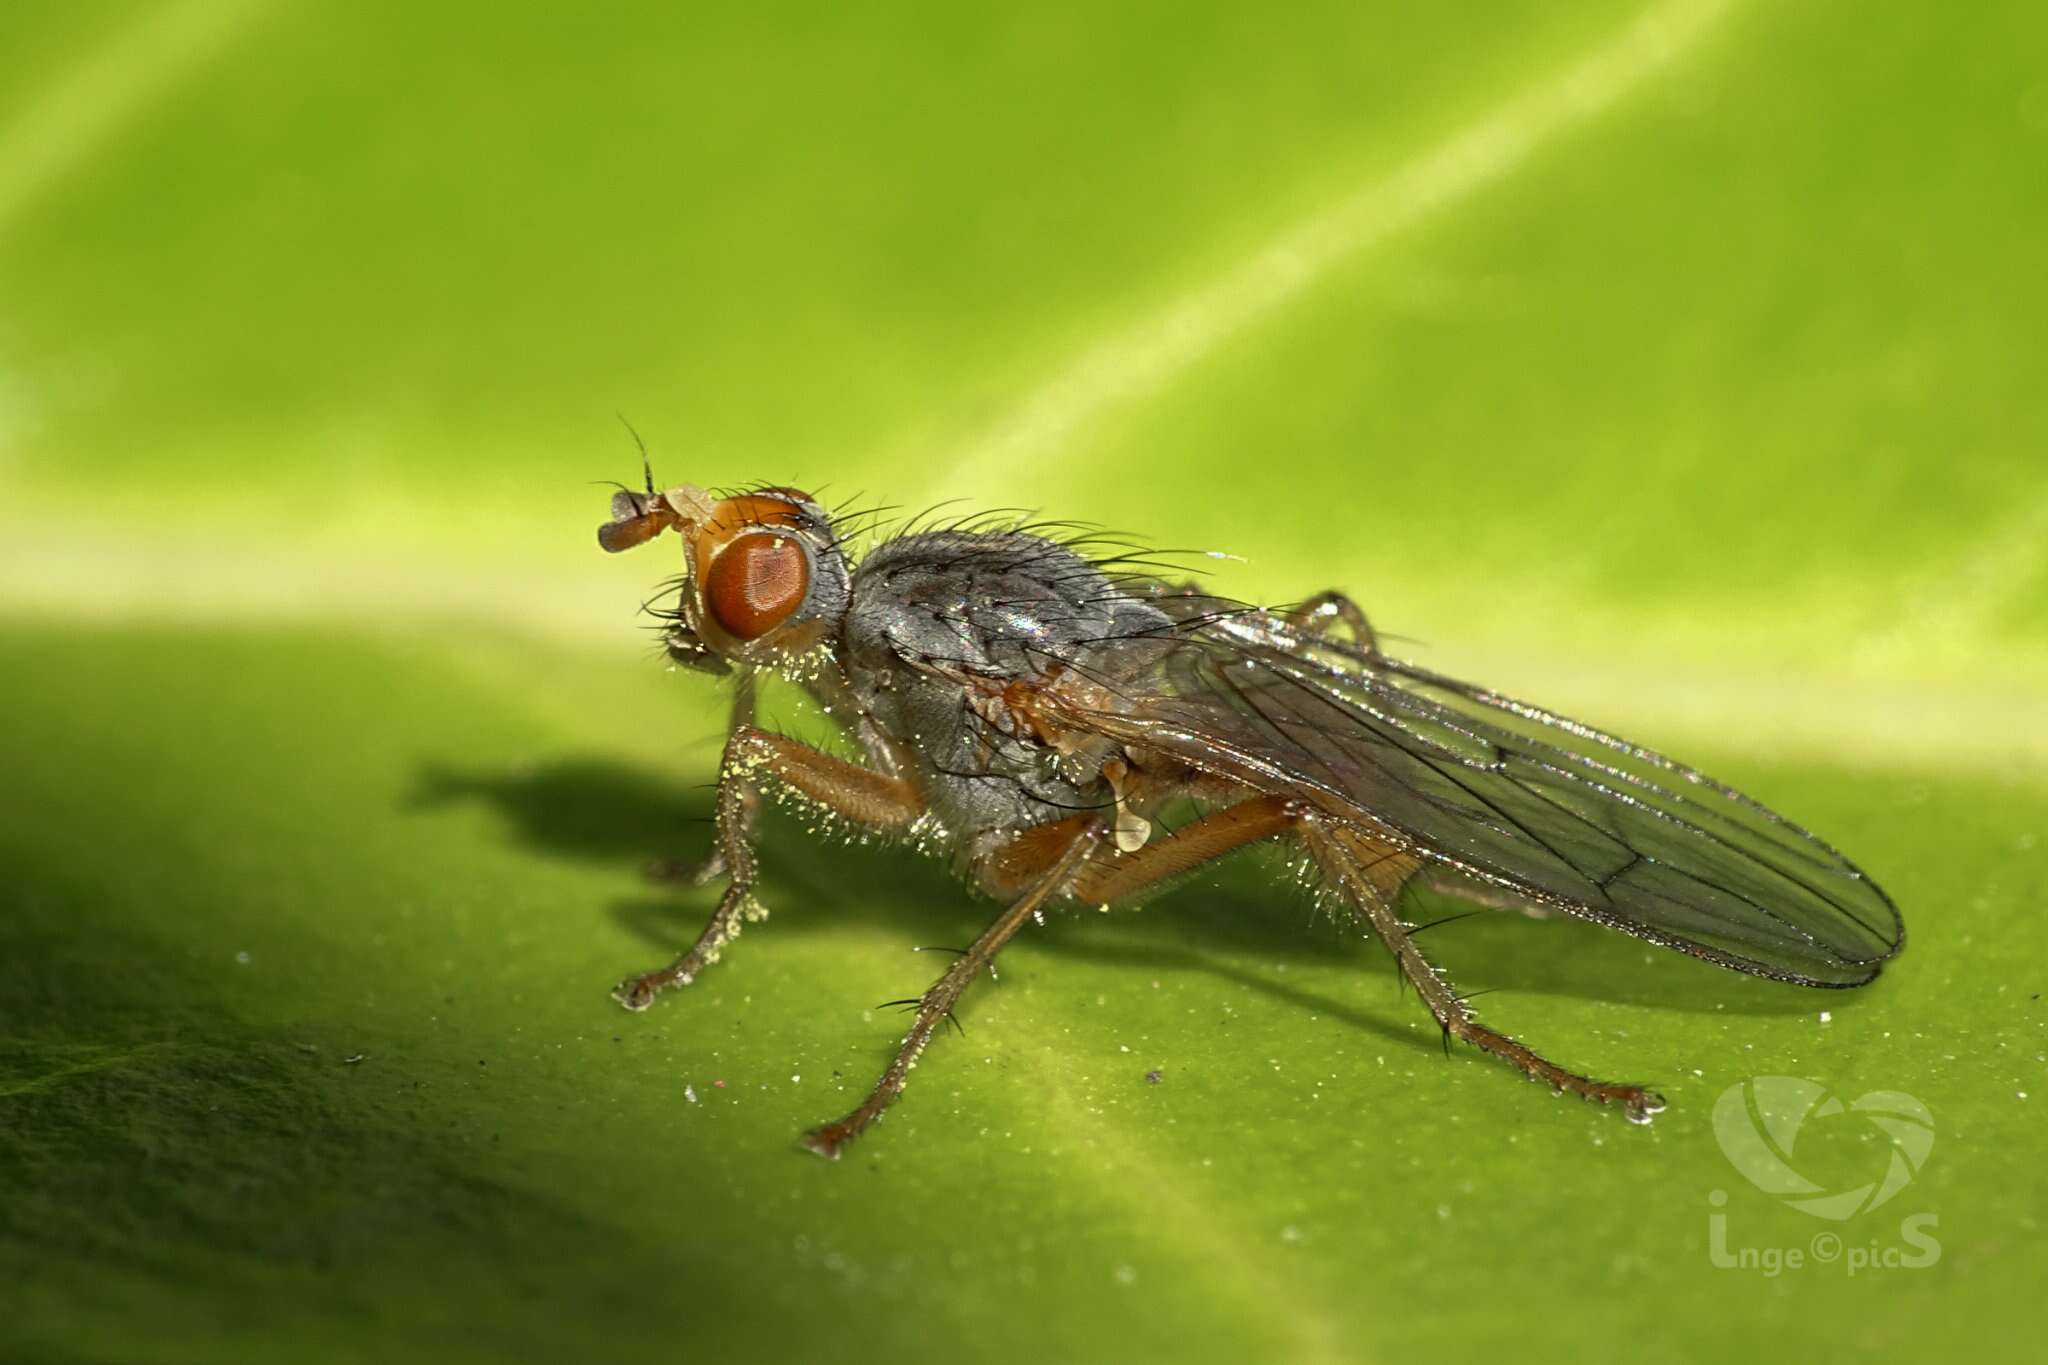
[419, 759, 1868, 1046]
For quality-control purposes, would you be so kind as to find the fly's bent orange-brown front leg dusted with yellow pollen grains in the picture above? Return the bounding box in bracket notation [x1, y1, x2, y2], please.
[612, 724, 924, 1009]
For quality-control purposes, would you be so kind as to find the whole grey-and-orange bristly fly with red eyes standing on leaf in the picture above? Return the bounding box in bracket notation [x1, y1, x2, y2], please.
[598, 477, 1905, 1156]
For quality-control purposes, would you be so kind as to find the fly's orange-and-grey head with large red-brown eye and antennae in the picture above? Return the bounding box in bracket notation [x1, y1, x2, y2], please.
[598, 483, 852, 673]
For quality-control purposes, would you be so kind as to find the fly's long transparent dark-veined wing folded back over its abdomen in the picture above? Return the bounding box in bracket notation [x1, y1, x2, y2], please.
[1044, 600, 1905, 986]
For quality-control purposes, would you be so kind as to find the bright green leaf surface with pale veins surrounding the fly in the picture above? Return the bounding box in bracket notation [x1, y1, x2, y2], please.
[0, 0, 2048, 1361]
